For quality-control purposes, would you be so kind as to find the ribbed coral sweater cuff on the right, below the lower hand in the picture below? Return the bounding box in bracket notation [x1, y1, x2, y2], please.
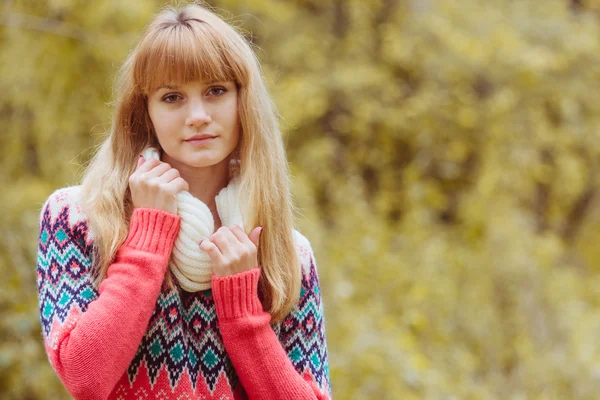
[212, 267, 263, 320]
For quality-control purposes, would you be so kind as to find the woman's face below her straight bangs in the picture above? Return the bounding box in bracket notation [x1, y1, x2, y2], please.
[148, 81, 240, 168]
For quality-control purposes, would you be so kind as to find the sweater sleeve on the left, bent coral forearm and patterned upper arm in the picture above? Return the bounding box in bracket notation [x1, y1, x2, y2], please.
[36, 191, 180, 400]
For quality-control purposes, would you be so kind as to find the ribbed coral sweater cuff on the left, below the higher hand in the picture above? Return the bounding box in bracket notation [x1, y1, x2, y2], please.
[123, 208, 181, 257]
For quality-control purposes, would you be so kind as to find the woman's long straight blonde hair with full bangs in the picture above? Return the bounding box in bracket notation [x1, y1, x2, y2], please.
[82, 3, 301, 323]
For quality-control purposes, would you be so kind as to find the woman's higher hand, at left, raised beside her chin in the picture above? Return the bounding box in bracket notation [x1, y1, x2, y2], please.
[129, 155, 189, 214]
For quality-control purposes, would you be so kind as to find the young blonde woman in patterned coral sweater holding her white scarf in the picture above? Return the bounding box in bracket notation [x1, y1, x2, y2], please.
[37, 4, 331, 400]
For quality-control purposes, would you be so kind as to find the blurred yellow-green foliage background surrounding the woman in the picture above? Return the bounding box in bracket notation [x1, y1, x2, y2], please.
[0, 0, 600, 400]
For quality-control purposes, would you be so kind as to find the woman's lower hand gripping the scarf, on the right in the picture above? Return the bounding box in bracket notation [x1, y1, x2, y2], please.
[200, 225, 263, 277]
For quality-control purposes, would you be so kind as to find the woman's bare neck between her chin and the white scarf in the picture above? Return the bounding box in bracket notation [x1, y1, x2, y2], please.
[162, 154, 230, 215]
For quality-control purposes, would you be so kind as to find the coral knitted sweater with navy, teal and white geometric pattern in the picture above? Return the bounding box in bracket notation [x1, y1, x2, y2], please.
[37, 186, 331, 400]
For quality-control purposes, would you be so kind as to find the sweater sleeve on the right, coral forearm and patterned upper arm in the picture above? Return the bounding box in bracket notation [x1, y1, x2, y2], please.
[213, 239, 331, 400]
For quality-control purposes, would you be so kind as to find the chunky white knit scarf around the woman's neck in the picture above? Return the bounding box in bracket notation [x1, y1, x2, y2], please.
[142, 147, 244, 292]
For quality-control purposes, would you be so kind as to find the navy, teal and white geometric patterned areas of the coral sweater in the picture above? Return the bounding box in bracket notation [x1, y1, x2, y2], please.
[36, 186, 332, 398]
